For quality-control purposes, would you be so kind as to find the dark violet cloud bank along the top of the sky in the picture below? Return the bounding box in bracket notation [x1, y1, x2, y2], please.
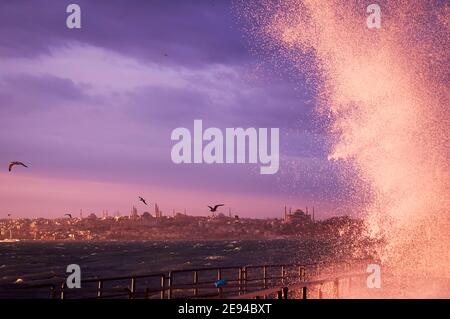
[0, 0, 249, 67]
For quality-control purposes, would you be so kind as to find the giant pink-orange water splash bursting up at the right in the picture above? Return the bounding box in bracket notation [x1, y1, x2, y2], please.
[240, 0, 450, 296]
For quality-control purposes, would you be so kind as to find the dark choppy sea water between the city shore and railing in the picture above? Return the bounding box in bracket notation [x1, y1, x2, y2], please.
[0, 239, 333, 298]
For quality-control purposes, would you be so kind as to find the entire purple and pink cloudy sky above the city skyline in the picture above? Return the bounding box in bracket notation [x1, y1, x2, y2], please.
[0, 0, 360, 218]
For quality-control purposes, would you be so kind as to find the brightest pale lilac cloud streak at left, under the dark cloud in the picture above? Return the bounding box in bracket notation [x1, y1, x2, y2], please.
[0, 43, 186, 95]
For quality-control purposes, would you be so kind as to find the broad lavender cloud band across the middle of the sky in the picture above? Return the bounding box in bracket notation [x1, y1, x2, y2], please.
[0, 43, 338, 201]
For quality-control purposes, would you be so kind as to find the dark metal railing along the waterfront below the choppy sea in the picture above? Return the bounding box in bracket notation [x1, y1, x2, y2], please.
[22, 261, 367, 299]
